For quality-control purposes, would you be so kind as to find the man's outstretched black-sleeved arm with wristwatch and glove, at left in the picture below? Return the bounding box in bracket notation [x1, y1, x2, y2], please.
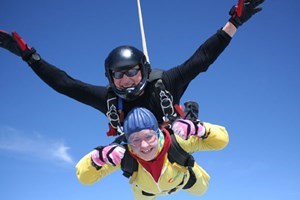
[0, 30, 107, 113]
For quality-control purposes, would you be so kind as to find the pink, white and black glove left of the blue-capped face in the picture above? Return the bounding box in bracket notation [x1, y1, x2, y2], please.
[92, 144, 126, 167]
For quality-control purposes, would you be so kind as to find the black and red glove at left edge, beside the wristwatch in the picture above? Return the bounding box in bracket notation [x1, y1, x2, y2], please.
[0, 30, 36, 62]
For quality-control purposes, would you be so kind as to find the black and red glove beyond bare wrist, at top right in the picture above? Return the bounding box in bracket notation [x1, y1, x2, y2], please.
[229, 0, 265, 28]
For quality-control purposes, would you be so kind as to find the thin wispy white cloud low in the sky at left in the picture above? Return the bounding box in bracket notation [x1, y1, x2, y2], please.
[0, 126, 74, 165]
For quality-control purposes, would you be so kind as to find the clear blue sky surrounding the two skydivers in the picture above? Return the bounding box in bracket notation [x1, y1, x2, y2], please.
[0, 0, 300, 200]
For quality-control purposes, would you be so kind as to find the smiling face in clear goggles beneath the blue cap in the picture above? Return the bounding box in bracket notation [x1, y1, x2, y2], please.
[128, 129, 158, 161]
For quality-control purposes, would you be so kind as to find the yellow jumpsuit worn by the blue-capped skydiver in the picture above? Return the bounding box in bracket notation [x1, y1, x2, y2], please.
[76, 122, 229, 200]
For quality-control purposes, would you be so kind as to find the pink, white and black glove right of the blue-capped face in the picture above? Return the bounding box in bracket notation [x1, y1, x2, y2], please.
[172, 119, 205, 140]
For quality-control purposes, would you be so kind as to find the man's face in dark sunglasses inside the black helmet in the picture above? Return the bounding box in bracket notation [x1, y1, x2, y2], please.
[112, 65, 142, 90]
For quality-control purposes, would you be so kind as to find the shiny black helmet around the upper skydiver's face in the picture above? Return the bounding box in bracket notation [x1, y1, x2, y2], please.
[105, 45, 151, 100]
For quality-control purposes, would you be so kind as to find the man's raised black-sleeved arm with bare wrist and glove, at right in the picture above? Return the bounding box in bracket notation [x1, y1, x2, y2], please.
[163, 0, 264, 103]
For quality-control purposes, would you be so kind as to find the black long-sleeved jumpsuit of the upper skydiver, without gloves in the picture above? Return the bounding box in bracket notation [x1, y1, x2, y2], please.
[31, 30, 231, 122]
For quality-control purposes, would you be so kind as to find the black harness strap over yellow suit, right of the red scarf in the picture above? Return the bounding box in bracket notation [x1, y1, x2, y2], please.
[168, 130, 195, 167]
